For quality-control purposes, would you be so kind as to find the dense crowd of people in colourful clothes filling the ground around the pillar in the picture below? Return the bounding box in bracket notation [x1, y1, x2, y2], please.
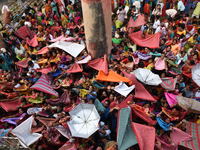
[0, 0, 200, 150]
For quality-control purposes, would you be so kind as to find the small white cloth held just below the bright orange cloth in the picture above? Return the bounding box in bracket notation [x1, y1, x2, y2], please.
[114, 82, 135, 97]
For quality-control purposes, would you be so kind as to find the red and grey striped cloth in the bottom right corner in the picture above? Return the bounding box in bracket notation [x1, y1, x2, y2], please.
[180, 121, 200, 150]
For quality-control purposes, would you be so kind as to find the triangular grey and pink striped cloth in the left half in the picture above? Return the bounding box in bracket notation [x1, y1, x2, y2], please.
[30, 75, 58, 96]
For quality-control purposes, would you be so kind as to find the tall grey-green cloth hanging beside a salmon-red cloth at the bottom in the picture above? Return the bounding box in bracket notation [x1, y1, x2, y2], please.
[117, 107, 138, 150]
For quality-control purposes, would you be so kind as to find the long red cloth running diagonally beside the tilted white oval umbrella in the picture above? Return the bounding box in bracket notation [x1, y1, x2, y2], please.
[121, 70, 156, 102]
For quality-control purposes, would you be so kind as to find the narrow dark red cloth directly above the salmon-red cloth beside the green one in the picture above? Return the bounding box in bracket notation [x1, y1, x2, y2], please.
[132, 104, 157, 125]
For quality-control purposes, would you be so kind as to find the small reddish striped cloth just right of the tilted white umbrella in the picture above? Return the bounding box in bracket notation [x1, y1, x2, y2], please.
[160, 77, 177, 90]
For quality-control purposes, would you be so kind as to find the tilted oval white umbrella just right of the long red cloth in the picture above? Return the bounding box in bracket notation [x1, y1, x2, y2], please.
[133, 68, 162, 85]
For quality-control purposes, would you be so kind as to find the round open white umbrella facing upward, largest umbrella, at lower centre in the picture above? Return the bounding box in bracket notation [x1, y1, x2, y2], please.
[67, 103, 100, 138]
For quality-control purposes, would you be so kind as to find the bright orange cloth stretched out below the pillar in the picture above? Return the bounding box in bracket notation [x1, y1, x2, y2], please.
[96, 70, 132, 85]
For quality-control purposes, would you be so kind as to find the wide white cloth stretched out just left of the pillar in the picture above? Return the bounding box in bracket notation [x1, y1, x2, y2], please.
[47, 41, 85, 57]
